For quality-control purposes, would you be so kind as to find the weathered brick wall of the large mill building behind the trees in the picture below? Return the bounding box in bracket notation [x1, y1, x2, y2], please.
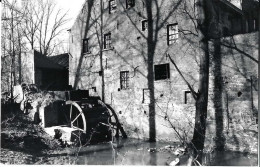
[69, 0, 259, 145]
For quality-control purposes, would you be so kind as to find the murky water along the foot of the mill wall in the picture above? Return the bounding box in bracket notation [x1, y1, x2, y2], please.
[50, 139, 257, 166]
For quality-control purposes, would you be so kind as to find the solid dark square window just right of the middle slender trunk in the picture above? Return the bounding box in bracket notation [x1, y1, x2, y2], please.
[154, 63, 170, 80]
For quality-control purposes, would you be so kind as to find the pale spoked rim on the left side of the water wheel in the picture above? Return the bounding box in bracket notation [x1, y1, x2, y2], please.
[64, 101, 87, 133]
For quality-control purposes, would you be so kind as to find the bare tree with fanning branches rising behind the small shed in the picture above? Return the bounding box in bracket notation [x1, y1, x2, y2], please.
[22, 0, 68, 56]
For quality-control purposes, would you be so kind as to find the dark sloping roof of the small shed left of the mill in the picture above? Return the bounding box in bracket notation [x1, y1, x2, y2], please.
[34, 50, 64, 70]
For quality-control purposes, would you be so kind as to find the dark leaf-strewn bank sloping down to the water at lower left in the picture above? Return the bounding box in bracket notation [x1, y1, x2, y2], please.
[0, 105, 61, 164]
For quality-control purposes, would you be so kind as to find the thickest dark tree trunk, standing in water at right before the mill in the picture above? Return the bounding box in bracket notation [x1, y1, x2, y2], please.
[190, 0, 211, 164]
